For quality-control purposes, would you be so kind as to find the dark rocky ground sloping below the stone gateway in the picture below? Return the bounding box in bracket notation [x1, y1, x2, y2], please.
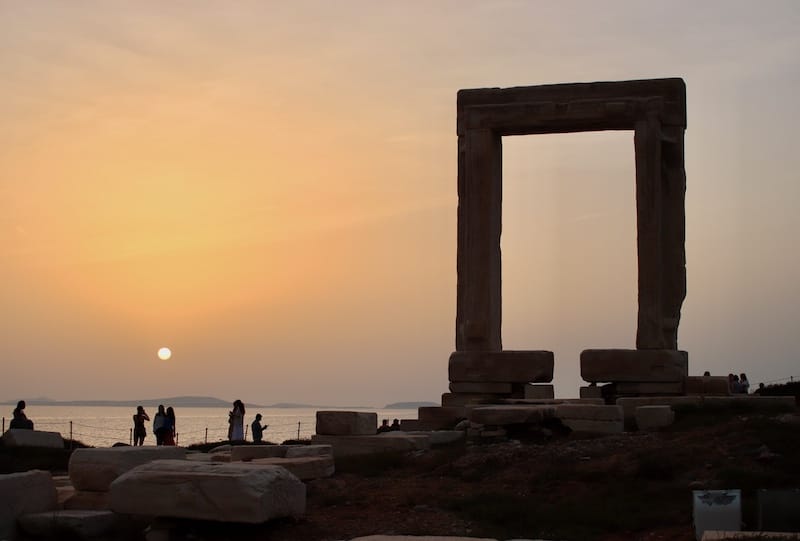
[3, 404, 800, 541]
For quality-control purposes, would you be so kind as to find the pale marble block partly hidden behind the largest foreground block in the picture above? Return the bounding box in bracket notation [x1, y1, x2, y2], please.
[69, 445, 186, 492]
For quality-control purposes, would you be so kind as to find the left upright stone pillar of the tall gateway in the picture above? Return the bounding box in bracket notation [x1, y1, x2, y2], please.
[456, 129, 503, 351]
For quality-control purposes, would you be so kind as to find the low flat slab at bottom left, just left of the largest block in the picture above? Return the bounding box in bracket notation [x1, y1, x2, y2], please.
[19, 510, 117, 539]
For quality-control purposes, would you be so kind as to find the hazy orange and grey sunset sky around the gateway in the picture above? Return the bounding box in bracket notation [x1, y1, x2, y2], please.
[0, 0, 800, 406]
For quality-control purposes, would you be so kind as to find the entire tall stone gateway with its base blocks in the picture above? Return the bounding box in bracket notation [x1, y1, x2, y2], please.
[450, 78, 688, 400]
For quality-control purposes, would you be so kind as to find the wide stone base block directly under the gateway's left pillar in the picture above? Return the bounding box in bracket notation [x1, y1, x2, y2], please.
[447, 350, 553, 383]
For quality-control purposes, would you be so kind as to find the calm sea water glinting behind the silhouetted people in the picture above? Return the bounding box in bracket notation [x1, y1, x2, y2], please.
[5, 405, 417, 447]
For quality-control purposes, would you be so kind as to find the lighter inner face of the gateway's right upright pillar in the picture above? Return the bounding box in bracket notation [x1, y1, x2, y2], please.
[633, 114, 666, 349]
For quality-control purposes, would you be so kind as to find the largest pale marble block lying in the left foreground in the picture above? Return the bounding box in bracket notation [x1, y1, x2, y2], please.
[111, 460, 306, 524]
